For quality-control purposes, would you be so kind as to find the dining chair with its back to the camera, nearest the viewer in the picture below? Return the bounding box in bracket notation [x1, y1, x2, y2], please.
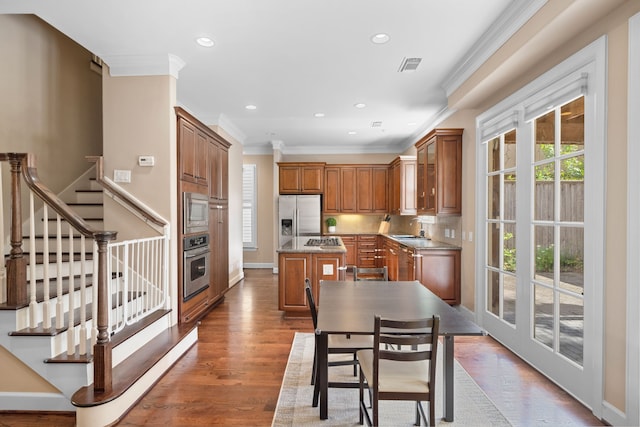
[357, 315, 440, 426]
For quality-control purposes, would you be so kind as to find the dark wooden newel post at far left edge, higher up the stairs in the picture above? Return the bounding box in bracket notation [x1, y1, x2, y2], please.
[6, 153, 28, 306]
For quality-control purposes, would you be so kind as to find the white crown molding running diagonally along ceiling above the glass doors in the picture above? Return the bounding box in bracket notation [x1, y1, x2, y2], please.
[442, 0, 548, 97]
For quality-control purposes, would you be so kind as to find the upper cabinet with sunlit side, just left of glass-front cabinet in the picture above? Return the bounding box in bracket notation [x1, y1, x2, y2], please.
[388, 156, 417, 215]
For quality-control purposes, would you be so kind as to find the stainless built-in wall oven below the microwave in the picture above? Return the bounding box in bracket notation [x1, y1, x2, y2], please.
[182, 234, 210, 301]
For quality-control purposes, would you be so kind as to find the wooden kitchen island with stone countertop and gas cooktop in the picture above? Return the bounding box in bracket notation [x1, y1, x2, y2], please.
[277, 236, 347, 317]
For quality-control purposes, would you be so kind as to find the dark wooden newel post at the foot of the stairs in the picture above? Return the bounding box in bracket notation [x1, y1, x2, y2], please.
[93, 231, 117, 393]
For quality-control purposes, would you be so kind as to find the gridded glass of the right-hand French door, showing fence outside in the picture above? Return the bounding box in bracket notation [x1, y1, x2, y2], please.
[531, 97, 585, 366]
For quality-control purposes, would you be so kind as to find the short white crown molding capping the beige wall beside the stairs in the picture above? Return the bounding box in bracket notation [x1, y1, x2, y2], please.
[100, 54, 186, 79]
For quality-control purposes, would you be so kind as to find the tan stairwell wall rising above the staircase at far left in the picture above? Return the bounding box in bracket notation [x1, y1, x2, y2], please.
[0, 15, 102, 237]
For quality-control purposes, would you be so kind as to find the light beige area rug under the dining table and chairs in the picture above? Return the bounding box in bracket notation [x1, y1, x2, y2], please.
[272, 332, 511, 427]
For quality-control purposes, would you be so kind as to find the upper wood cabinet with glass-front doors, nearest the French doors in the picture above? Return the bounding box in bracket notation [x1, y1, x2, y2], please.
[415, 129, 463, 215]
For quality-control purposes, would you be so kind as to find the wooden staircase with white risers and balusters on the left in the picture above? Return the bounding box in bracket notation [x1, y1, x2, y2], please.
[0, 154, 197, 426]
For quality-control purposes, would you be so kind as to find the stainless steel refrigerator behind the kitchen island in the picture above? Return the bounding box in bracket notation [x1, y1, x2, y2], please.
[278, 195, 322, 246]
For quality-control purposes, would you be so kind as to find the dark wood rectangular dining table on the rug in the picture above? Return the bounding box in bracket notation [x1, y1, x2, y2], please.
[316, 280, 485, 422]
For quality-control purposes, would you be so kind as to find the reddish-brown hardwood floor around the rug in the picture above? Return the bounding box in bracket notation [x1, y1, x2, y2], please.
[0, 270, 603, 427]
